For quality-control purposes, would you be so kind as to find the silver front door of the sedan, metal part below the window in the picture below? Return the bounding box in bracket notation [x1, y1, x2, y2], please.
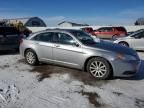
[53, 44, 83, 66]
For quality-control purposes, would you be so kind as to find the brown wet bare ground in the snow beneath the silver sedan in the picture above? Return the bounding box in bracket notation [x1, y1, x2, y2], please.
[31, 64, 108, 86]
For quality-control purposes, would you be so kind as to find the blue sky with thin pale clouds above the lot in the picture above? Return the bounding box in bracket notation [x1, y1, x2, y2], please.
[0, 0, 144, 26]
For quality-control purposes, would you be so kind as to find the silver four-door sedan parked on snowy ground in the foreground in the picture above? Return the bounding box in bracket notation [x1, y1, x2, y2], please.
[20, 29, 140, 80]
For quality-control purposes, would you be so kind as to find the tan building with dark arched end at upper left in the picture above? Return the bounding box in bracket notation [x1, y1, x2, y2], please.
[3, 17, 46, 27]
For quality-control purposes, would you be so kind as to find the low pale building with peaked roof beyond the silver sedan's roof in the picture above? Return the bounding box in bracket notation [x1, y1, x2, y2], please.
[58, 21, 89, 27]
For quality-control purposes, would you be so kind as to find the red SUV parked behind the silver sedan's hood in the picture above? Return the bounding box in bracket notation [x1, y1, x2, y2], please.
[92, 27, 127, 39]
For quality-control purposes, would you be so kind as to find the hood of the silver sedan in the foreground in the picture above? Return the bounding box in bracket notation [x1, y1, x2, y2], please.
[89, 40, 136, 56]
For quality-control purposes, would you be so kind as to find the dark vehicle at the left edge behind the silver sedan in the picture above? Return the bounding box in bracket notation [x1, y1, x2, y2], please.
[0, 27, 23, 50]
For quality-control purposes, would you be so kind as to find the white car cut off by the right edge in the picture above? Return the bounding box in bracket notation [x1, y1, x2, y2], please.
[114, 29, 144, 50]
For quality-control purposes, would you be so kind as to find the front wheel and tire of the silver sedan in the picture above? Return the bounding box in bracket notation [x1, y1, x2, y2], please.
[86, 57, 112, 80]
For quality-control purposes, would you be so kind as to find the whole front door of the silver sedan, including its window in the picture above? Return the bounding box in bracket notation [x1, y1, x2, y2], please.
[53, 33, 83, 68]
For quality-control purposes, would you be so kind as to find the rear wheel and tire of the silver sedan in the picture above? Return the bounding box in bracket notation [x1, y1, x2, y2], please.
[25, 49, 39, 66]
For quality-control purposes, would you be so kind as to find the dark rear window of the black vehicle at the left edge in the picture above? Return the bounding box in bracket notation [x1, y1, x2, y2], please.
[0, 27, 19, 35]
